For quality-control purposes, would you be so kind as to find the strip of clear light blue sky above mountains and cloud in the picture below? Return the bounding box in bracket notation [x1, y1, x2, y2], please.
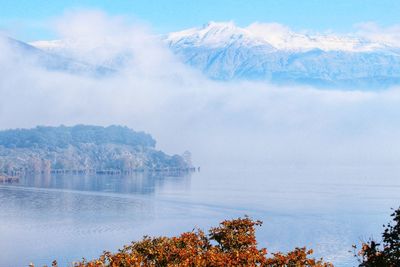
[0, 0, 400, 41]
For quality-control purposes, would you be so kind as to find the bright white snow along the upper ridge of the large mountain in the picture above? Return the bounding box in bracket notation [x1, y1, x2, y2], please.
[165, 22, 387, 52]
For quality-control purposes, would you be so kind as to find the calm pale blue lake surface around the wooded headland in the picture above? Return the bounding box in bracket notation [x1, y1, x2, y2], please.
[0, 166, 400, 267]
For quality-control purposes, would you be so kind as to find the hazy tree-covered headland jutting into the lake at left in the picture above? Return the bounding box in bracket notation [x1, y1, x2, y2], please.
[0, 125, 190, 175]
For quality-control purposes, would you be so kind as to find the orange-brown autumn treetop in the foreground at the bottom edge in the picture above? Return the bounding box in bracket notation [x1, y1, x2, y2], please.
[49, 217, 333, 267]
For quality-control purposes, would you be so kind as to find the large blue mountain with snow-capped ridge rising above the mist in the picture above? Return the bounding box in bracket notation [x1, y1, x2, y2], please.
[164, 22, 400, 87]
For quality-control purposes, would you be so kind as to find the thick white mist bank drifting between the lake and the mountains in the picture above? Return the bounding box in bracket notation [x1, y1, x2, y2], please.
[0, 11, 400, 170]
